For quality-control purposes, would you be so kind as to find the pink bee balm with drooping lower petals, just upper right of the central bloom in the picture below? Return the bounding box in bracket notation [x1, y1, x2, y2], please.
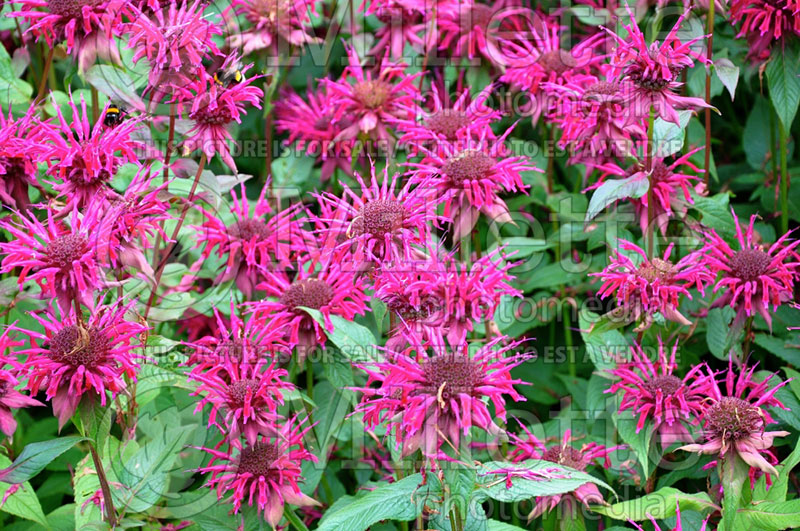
[407, 127, 540, 241]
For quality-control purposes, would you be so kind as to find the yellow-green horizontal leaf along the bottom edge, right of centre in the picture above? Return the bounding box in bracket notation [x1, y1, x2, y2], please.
[591, 487, 719, 521]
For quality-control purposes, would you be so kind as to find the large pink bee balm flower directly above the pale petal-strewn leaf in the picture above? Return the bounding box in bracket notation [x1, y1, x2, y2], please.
[357, 337, 528, 459]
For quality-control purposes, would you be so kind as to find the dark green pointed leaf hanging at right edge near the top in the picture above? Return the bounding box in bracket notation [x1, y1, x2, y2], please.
[766, 41, 800, 131]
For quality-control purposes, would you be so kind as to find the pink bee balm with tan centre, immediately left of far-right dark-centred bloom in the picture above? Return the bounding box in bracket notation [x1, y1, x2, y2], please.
[590, 240, 713, 330]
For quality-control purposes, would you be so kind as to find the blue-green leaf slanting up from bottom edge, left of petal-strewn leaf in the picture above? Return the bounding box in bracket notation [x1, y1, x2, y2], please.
[317, 473, 439, 531]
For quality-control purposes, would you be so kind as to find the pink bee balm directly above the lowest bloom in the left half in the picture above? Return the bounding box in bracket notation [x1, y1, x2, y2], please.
[189, 328, 294, 447]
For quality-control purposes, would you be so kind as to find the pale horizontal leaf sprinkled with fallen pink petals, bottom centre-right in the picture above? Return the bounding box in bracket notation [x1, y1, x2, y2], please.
[475, 459, 613, 502]
